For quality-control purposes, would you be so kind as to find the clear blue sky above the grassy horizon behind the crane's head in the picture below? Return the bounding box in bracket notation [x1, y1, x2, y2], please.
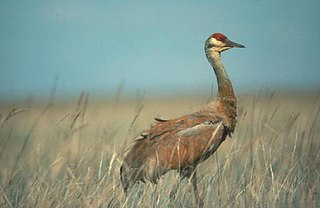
[0, 0, 320, 98]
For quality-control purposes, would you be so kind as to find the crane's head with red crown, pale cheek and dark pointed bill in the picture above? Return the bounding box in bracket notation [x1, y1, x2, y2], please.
[205, 33, 244, 53]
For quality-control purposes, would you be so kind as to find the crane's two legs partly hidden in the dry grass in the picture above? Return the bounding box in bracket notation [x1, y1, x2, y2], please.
[170, 168, 203, 208]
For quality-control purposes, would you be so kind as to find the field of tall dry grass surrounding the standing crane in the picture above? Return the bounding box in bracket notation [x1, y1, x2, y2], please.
[0, 92, 320, 207]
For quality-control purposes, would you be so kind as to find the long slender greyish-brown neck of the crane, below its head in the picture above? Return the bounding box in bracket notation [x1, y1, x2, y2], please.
[205, 48, 235, 100]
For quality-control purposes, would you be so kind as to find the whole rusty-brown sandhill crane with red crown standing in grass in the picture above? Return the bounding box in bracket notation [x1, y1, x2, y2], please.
[120, 33, 244, 207]
